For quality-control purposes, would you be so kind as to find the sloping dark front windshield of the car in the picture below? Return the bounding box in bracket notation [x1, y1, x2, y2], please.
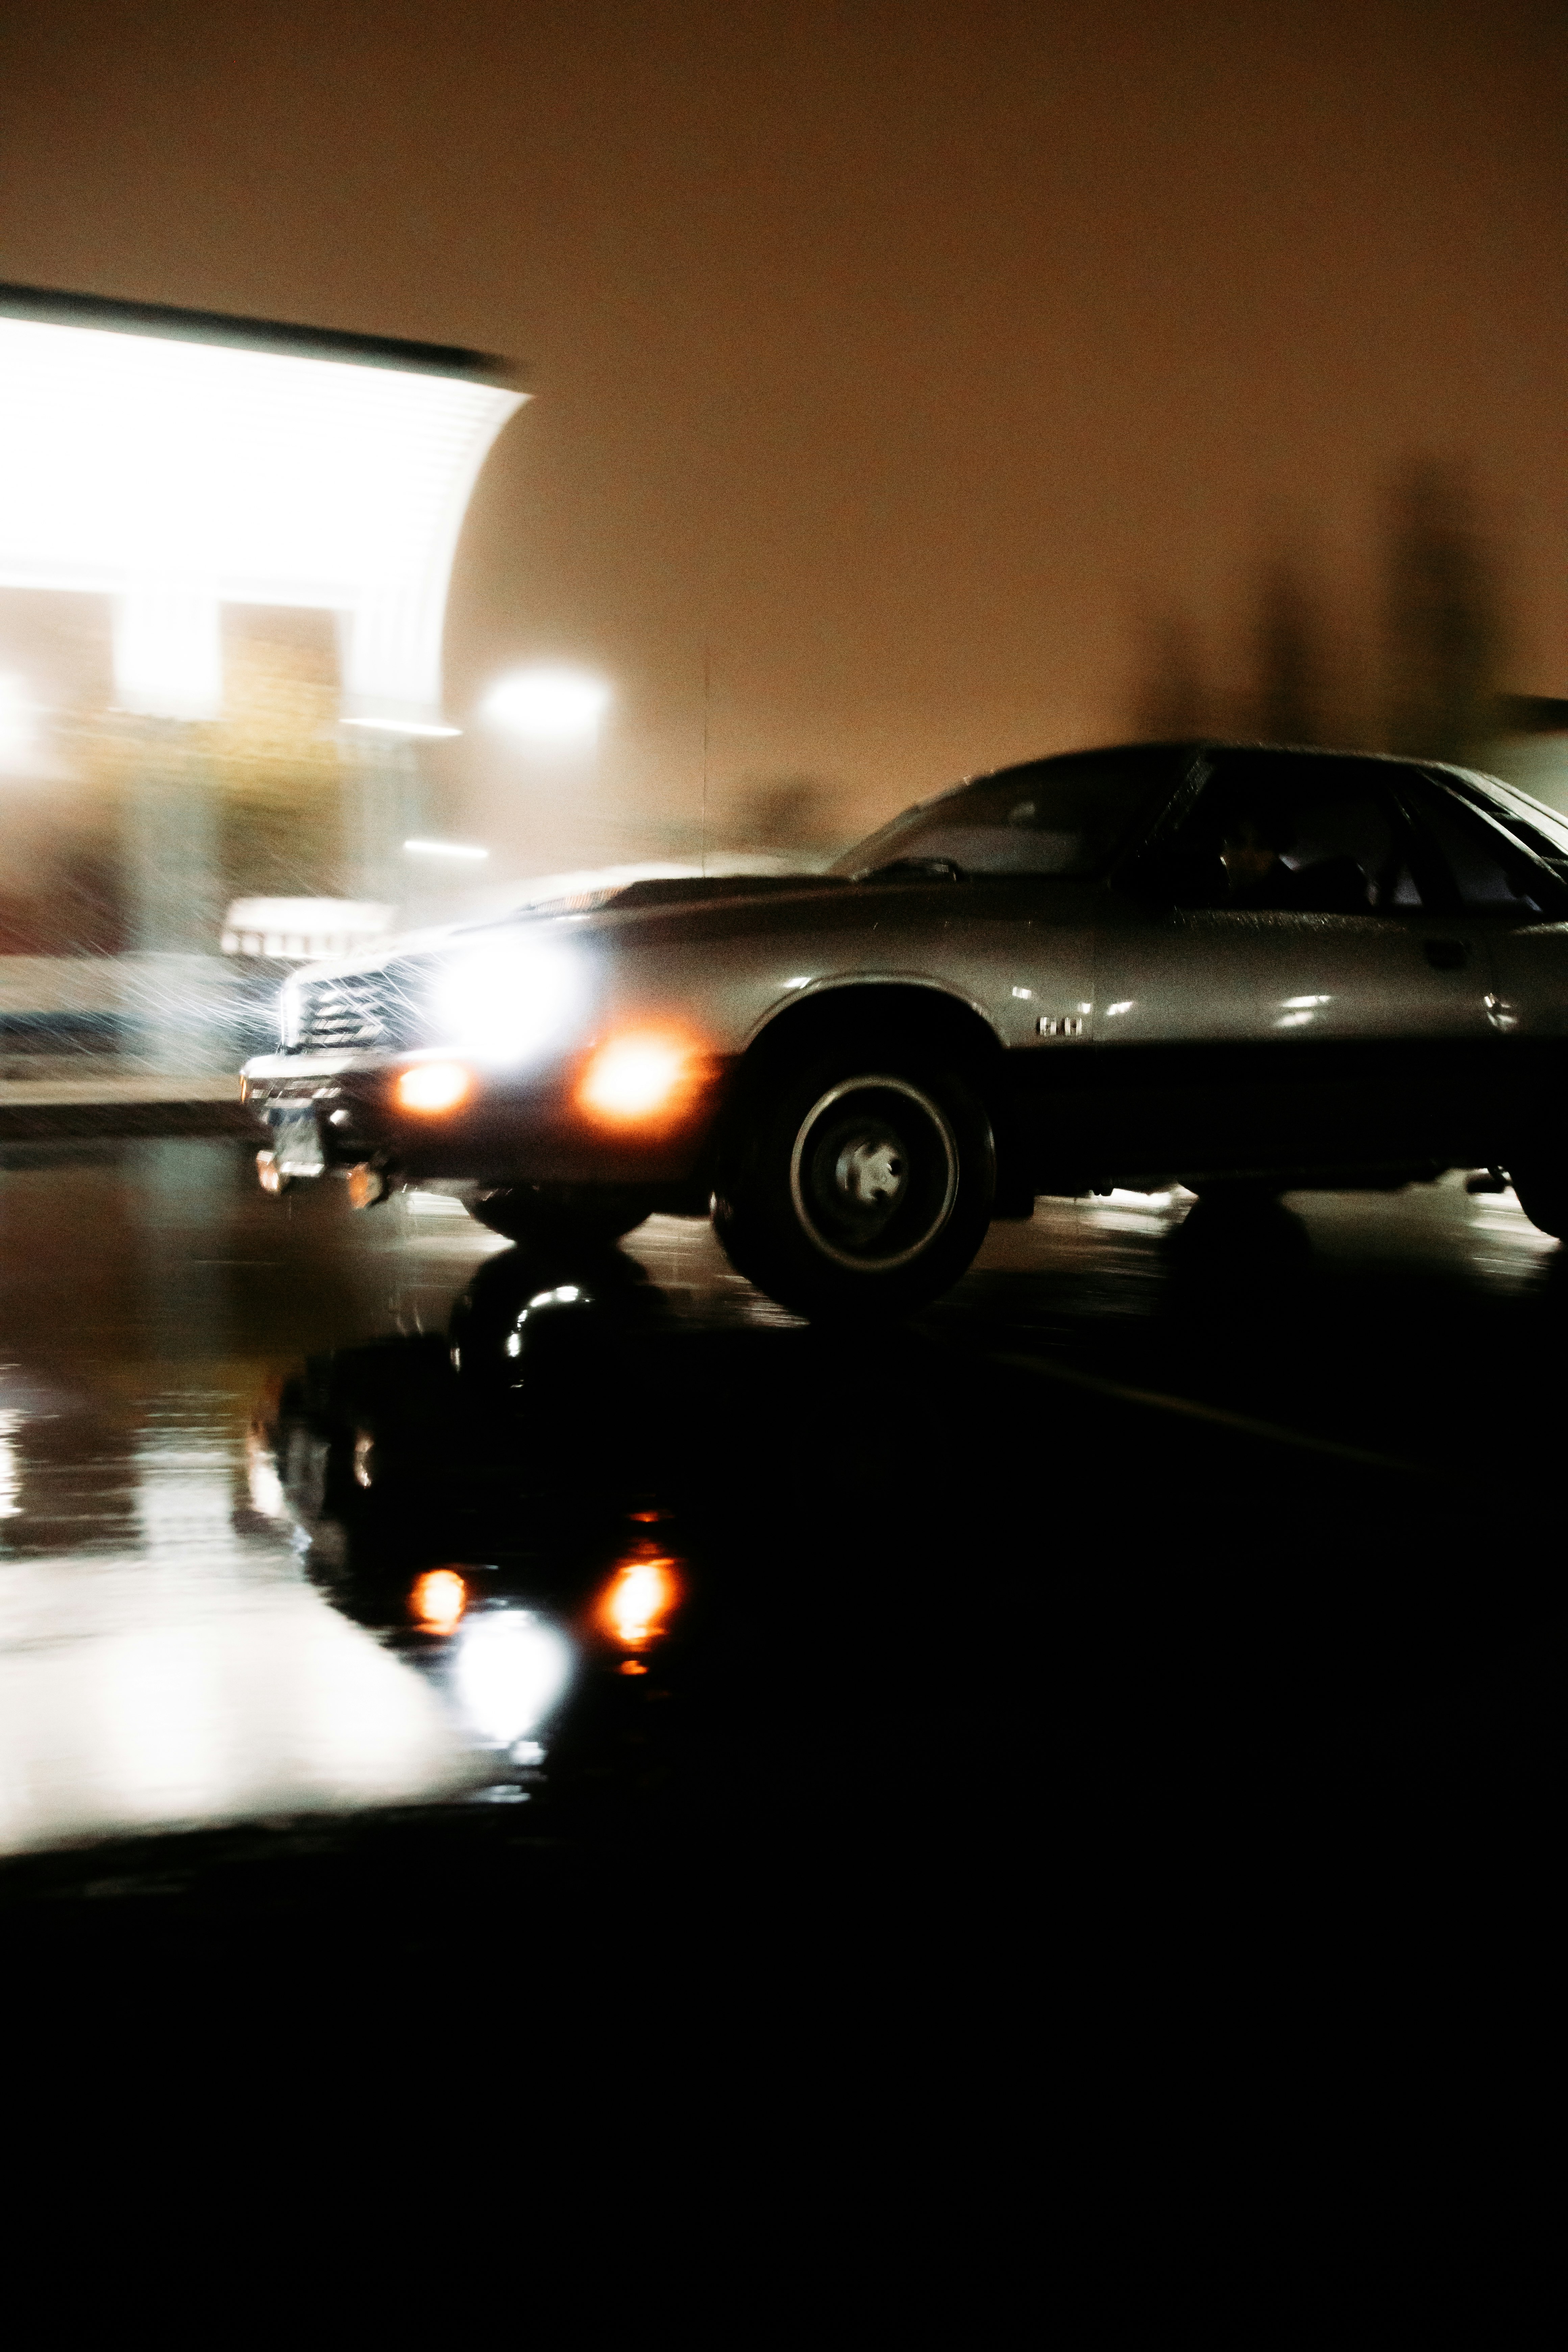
[830, 743, 1178, 880]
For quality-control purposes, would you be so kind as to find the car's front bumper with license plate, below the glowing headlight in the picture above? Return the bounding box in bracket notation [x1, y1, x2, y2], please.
[240, 1054, 727, 1185]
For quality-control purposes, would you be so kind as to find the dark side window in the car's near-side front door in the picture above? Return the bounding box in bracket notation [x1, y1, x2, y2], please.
[1168, 753, 1425, 915]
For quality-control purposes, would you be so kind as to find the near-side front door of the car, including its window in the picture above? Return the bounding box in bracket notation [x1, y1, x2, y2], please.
[1093, 750, 1497, 1174]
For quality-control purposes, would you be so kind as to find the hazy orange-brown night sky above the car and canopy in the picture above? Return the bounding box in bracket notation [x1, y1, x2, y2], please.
[0, 0, 1568, 865]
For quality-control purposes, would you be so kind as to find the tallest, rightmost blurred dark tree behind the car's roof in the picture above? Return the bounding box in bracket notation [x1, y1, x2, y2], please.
[1387, 459, 1504, 760]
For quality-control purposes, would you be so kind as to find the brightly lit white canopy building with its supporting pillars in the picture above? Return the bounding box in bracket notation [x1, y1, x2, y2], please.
[0, 287, 524, 1058]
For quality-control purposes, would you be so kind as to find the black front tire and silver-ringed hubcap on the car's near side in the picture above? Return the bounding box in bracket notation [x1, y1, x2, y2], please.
[712, 1039, 997, 1322]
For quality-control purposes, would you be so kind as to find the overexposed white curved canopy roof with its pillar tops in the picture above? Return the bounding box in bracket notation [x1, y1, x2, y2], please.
[0, 289, 524, 732]
